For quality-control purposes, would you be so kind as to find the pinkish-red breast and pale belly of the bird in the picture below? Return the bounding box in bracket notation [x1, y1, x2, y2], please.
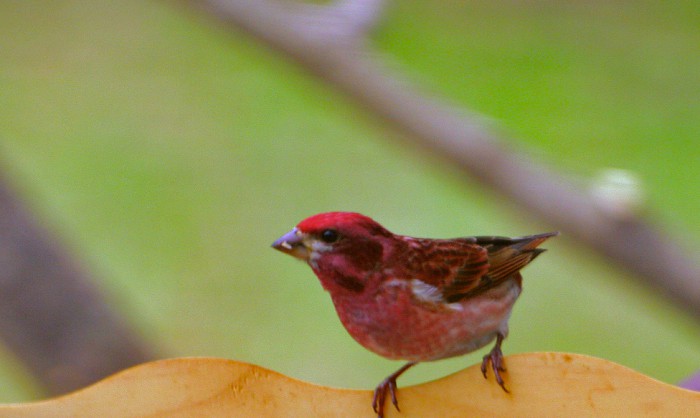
[331, 280, 520, 361]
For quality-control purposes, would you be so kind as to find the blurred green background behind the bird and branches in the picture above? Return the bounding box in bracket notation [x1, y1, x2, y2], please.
[0, 0, 700, 402]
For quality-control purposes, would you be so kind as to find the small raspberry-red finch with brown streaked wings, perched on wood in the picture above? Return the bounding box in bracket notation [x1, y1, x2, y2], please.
[272, 212, 559, 418]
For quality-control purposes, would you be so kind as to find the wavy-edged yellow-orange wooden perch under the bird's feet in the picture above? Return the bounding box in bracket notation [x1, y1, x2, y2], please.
[0, 353, 700, 418]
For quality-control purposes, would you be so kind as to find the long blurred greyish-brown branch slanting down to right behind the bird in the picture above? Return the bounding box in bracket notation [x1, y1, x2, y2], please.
[186, 0, 700, 318]
